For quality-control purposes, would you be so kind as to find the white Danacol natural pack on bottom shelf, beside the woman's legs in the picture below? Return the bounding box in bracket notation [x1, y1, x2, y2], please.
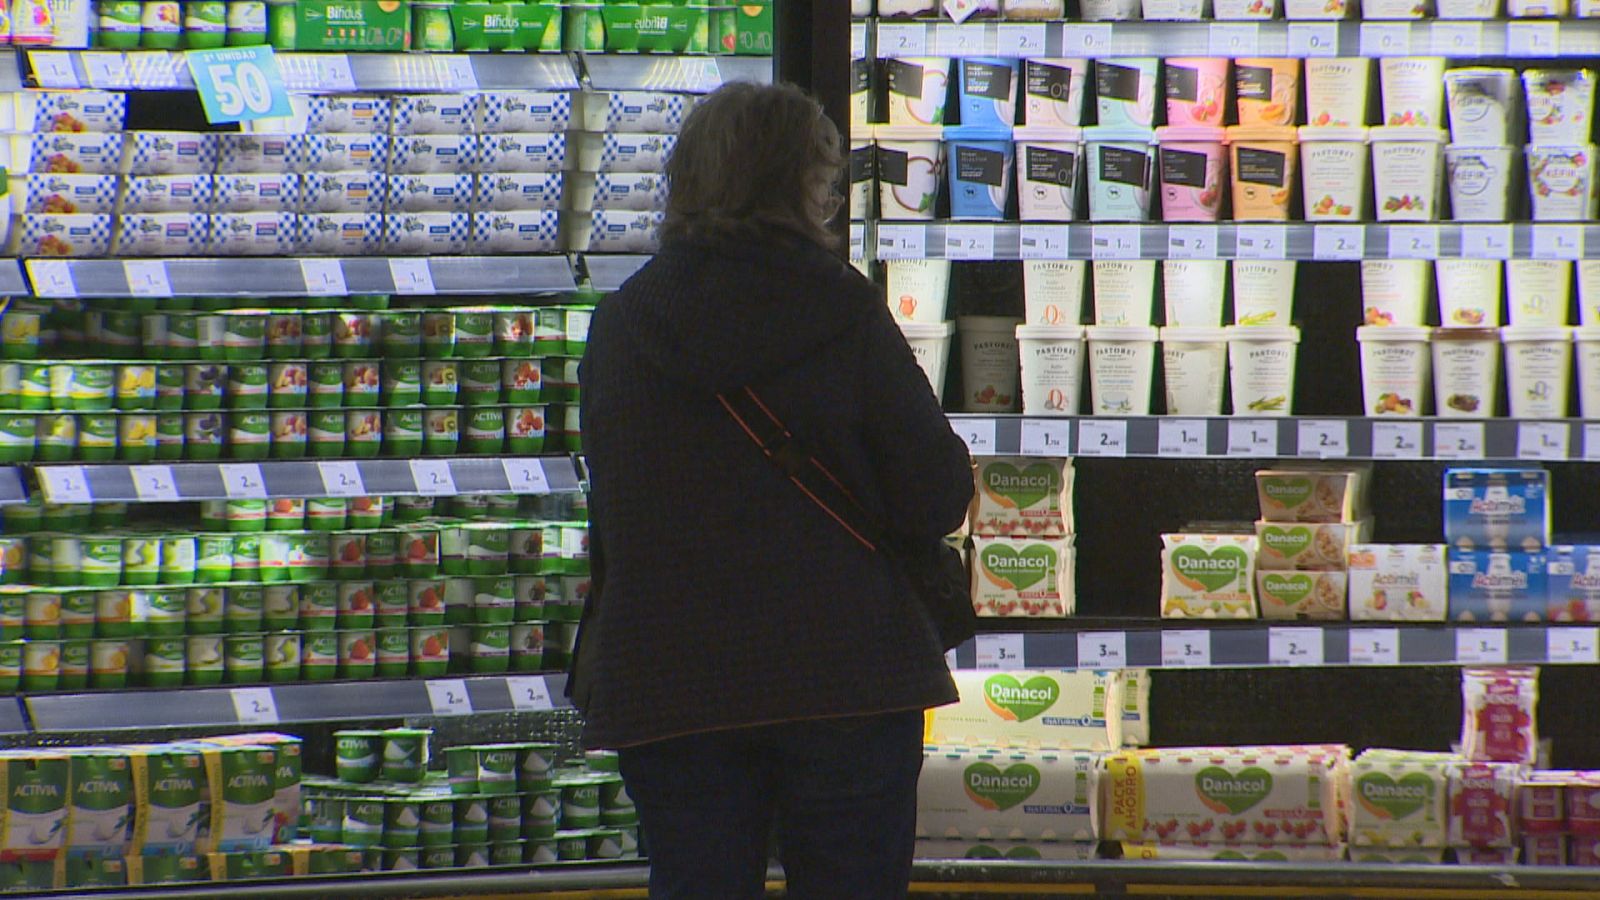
[917, 746, 1101, 841]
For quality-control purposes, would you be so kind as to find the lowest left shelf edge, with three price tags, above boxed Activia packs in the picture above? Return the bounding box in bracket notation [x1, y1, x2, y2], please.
[23, 674, 568, 733]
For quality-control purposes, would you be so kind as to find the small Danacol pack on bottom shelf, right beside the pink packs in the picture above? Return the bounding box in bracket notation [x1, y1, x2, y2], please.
[1350, 749, 1461, 849]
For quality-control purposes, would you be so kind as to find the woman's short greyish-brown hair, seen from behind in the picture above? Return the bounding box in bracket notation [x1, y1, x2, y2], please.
[661, 82, 845, 247]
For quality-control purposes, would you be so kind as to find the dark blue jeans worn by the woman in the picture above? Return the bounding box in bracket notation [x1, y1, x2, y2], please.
[621, 711, 922, 900]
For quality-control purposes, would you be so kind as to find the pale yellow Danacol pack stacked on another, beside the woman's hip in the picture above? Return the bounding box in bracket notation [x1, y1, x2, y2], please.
[923, 669, 1123, 749]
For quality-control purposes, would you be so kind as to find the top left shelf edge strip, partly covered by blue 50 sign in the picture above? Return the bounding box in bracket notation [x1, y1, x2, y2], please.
[21, 50, 578, 93]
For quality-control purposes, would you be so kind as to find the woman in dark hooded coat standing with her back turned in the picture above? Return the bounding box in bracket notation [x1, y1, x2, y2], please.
[574, 83, 973, 898]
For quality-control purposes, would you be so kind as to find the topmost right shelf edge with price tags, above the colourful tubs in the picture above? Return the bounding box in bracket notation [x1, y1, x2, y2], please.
[876, 21, 1600, 59]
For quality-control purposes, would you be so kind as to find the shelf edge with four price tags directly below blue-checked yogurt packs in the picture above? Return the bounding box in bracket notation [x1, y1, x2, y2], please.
[21, 255, 578, 296]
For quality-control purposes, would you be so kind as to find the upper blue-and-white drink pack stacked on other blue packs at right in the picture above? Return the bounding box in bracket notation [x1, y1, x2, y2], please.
[1445, 468, 1550, 552]
